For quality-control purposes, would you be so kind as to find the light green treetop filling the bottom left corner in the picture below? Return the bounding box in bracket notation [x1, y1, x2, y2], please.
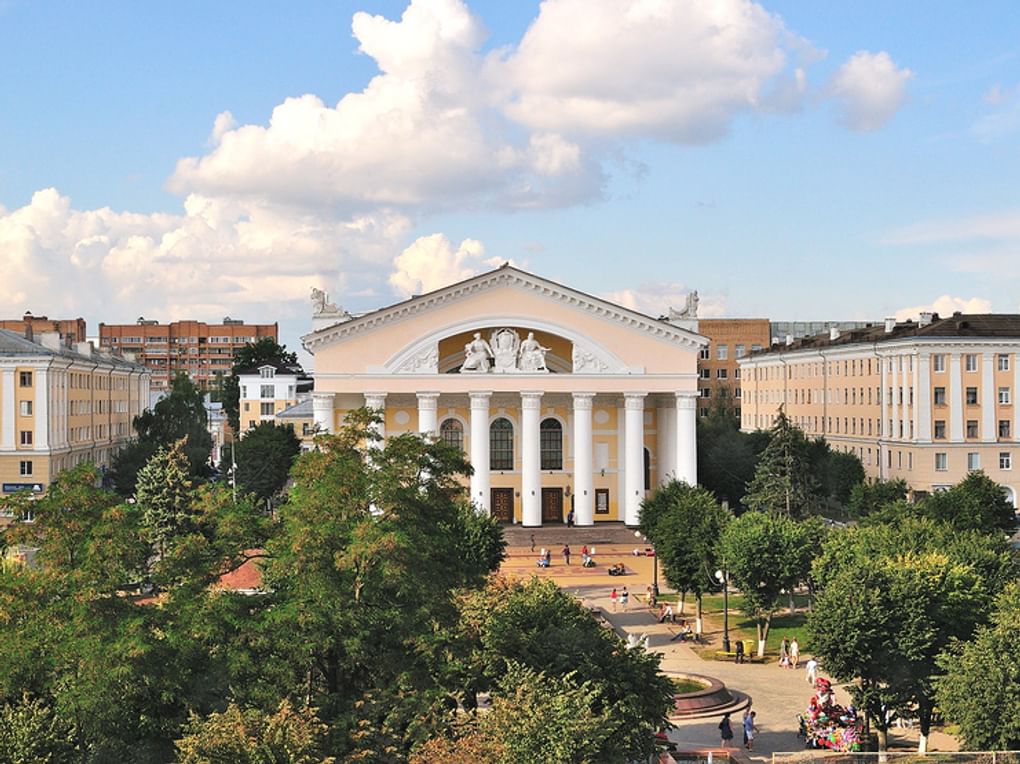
[0, 694, 81, 764]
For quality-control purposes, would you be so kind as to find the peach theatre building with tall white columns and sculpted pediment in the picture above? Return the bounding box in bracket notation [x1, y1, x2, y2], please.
[304, 266, 707, 526]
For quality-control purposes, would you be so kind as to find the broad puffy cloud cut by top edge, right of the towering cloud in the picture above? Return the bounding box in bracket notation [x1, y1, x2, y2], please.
[488, 0, 804, 144]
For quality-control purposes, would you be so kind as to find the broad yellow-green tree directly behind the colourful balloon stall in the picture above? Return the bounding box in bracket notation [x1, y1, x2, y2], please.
[808, 553, 987, 752]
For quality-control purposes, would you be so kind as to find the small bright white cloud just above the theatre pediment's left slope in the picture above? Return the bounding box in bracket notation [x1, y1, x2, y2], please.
[390, 234, 502, 297]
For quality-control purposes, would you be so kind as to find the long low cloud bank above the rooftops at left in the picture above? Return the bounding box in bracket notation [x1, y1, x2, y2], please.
[0, 189, 409, 317]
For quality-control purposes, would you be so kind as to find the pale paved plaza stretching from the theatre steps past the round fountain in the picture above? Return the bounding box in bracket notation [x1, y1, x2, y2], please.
[501, 528, 957, 760]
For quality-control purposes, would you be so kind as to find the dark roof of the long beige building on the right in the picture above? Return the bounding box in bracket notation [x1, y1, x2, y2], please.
[753, 313, 1020, 356]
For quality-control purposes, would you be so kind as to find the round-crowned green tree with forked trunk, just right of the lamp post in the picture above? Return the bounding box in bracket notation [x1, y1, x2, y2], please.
[719, 512, 814, 656]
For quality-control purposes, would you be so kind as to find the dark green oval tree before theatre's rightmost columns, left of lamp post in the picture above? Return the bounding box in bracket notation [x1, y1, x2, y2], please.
[641, 480, 729, 633]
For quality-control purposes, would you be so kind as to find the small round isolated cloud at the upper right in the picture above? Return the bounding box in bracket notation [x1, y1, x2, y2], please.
[830, 50, 913, 132]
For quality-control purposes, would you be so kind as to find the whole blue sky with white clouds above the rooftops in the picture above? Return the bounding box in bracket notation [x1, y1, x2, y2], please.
[0, 0, 1020, 361]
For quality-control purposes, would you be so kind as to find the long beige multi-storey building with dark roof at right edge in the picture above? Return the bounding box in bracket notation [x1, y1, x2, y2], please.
[740, 313, 1020, 507]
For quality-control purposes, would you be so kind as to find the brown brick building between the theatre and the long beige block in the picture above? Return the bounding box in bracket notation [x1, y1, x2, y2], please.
[696, 318, 770, 417]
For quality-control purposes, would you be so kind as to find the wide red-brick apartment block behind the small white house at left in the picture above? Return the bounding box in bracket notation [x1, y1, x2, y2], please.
[99, 316, 278, 392]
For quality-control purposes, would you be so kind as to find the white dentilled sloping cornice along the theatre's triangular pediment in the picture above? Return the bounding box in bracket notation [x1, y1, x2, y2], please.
[301, 265, 708, 355]
